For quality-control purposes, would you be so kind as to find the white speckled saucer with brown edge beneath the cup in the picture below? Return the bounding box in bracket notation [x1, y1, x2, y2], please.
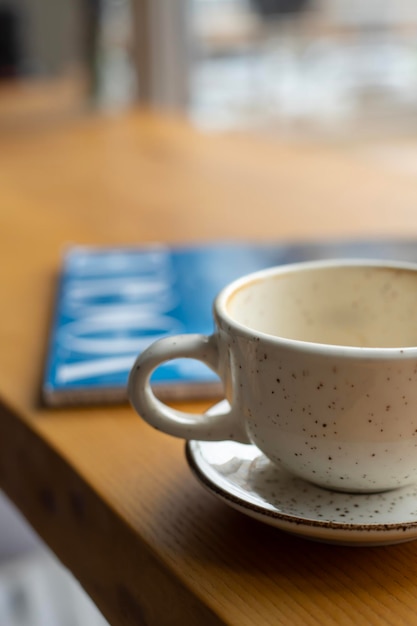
[186, 405, 417, 546]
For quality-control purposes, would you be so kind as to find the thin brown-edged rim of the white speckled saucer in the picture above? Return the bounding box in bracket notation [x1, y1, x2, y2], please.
[185, 440, 417, 534]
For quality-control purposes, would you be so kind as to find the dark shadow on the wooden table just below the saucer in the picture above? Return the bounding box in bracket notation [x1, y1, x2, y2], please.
[150, 474, 417, 600]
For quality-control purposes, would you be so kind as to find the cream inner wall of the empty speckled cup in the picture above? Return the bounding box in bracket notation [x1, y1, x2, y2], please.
[226, 265, 417, 348]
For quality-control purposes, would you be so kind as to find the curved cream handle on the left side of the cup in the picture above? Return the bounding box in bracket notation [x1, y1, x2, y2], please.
[128, 334, 250, 443]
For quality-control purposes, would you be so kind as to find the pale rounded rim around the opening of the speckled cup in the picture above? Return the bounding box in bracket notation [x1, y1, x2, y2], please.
[213, 258, 417, 359]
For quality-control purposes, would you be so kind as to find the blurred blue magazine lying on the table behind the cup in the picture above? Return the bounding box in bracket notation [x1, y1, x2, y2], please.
[42, 241, 417, 405]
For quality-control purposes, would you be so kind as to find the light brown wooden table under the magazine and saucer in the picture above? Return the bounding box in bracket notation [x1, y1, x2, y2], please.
[0, 95, 417, 626]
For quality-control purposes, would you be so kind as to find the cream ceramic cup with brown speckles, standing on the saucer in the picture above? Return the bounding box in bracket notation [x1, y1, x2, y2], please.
[128, 260, 417, 492]
